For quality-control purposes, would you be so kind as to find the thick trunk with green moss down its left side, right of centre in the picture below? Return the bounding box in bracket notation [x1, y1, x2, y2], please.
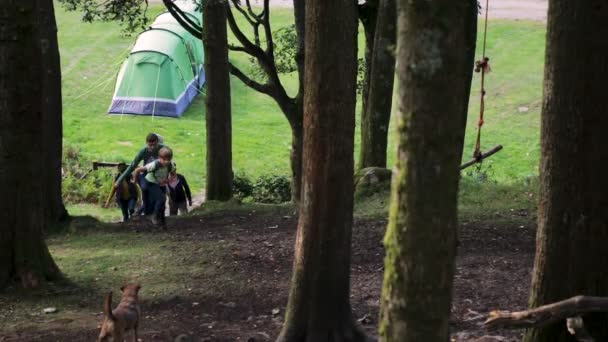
[380, 0, 477, 342]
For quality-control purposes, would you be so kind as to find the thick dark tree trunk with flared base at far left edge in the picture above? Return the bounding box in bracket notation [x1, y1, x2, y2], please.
[0, 0, 59, 288]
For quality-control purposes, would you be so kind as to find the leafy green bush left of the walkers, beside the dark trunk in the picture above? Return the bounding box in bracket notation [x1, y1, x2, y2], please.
[61, 146, 113, 203]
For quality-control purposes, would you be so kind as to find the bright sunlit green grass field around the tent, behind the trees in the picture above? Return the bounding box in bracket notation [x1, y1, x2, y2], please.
[57, 6, 545, 216]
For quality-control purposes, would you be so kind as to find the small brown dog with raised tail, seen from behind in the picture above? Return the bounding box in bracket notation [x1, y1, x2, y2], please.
[98, 284, 141, 342]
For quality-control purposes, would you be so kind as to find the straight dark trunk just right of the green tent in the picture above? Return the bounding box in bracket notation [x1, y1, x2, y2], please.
[203, 0, 232, 201]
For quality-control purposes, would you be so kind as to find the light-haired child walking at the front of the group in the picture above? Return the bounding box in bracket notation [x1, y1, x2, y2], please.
[135, 147, 174, 228]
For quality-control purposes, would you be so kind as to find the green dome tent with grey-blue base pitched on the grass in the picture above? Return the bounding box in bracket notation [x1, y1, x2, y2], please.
[108, 2, 205, 117]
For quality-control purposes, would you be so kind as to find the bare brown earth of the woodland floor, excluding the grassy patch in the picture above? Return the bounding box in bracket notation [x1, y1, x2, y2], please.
[0, 212, 534, 342]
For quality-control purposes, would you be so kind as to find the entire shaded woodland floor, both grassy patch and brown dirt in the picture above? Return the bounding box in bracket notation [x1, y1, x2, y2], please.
[0, 205, 534, 342]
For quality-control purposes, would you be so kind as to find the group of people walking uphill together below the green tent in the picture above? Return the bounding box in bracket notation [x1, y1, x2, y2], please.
[114, 133, 192, 227]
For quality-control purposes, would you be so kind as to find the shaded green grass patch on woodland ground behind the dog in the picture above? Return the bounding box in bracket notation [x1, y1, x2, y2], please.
[0, 223, 235, 334]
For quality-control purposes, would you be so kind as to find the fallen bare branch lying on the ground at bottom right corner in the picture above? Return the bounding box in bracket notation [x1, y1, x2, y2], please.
[484, 296, 608, 329]
